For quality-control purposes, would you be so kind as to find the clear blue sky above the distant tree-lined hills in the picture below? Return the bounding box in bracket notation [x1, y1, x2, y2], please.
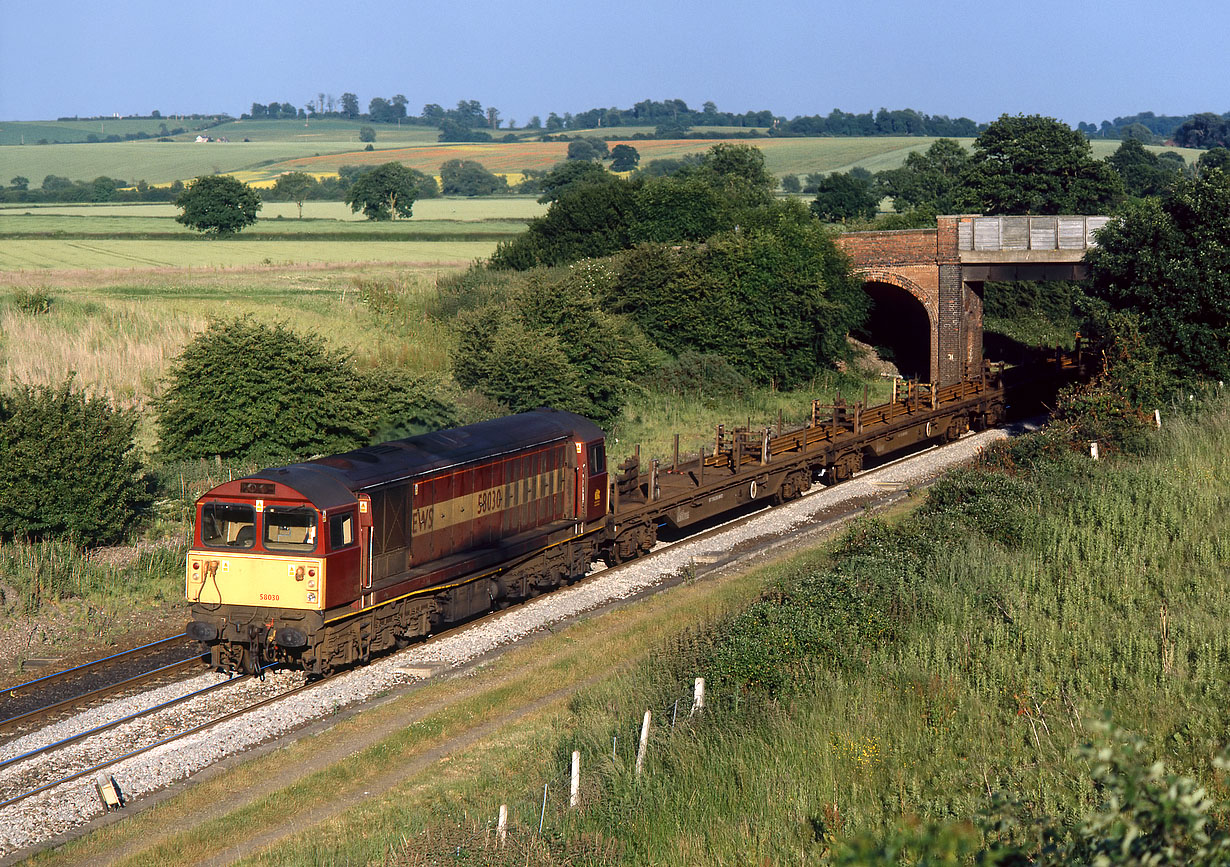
[0, 0, 1230, 124]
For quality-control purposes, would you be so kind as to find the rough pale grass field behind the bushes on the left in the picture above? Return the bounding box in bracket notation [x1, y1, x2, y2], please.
[0, 263, 466, 430]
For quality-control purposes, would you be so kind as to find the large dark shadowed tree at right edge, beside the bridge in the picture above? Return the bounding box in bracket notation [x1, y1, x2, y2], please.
[1086, 170, 1230, 380]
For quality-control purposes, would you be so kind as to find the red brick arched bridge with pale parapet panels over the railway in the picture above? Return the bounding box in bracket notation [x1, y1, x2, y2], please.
[836, 216, 1109, 385]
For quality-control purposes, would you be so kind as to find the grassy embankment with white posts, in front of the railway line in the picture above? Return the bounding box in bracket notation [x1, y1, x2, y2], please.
[36, 400, 1230, 865]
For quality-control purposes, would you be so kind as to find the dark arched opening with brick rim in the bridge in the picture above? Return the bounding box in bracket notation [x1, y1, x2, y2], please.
[852, 267, 940, 382]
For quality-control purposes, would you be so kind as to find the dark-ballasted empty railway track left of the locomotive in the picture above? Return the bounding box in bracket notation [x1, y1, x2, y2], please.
[0, 633, 204, 744]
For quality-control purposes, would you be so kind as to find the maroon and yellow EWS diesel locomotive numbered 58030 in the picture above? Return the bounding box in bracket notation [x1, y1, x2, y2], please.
[187, 410, 608, 674]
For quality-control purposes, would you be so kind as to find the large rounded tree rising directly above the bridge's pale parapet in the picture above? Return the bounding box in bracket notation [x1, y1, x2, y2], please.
[958, 114, 1123, 214]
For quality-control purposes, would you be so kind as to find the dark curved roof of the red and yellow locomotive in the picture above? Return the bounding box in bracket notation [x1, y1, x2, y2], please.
[250, 408, 603, 509]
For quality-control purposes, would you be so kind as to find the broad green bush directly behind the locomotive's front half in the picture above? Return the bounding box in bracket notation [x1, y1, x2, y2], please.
[156, 319, 453, 465]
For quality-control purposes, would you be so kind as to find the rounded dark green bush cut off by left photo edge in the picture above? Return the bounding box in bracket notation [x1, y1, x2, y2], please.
[0, 378, 149, 545]
